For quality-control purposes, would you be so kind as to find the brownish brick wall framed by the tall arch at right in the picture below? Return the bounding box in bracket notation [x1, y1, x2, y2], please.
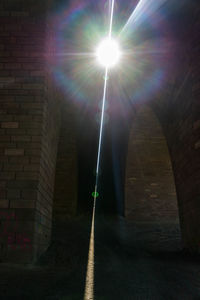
[125, 105, 179, 223]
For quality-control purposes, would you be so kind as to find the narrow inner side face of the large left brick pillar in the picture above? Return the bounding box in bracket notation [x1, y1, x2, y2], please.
[35, 80, 60, 256]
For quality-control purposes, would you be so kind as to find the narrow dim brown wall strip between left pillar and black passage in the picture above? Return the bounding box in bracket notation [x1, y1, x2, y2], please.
[53, 99, 78, 221]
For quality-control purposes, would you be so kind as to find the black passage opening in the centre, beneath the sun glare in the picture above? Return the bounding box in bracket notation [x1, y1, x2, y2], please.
[78, 108, 130, 216]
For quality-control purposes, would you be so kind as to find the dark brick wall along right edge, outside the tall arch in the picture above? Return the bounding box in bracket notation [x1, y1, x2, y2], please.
[153, 8, 200, 252]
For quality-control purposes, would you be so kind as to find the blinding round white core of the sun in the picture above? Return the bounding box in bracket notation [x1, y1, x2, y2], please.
[96, 38, 121, 68]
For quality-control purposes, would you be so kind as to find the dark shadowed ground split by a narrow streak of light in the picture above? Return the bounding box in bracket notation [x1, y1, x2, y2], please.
[0, 218, 200, 300]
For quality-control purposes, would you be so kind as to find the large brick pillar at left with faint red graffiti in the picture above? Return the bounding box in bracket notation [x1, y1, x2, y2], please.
[0, 0, 59, 262]
